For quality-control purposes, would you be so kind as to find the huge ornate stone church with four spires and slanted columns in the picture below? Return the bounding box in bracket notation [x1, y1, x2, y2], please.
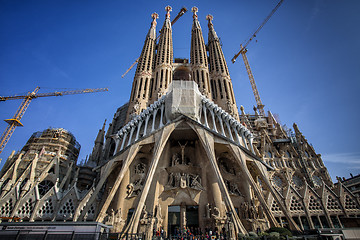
[0, 6, 360, 239]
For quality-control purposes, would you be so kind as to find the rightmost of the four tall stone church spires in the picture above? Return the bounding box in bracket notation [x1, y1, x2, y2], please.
[206, 14, 239, 120]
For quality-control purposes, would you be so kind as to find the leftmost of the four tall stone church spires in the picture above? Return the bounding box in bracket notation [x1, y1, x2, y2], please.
[126, 13, 159, 121]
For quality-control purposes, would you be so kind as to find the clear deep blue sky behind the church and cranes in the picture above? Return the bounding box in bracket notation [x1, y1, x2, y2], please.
[0, 0, 360, 180]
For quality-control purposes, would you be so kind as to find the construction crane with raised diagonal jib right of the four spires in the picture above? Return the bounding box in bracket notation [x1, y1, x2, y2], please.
[231, 0, 284, 116]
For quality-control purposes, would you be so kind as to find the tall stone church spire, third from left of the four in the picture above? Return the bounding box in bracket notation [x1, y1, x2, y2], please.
[190, 7, 211, 98]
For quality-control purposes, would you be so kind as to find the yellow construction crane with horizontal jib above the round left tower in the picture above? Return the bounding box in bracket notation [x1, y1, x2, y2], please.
[0, 87, 108, 154]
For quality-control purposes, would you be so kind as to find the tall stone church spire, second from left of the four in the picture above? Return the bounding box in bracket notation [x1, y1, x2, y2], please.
[151, 6, 173, 102]
